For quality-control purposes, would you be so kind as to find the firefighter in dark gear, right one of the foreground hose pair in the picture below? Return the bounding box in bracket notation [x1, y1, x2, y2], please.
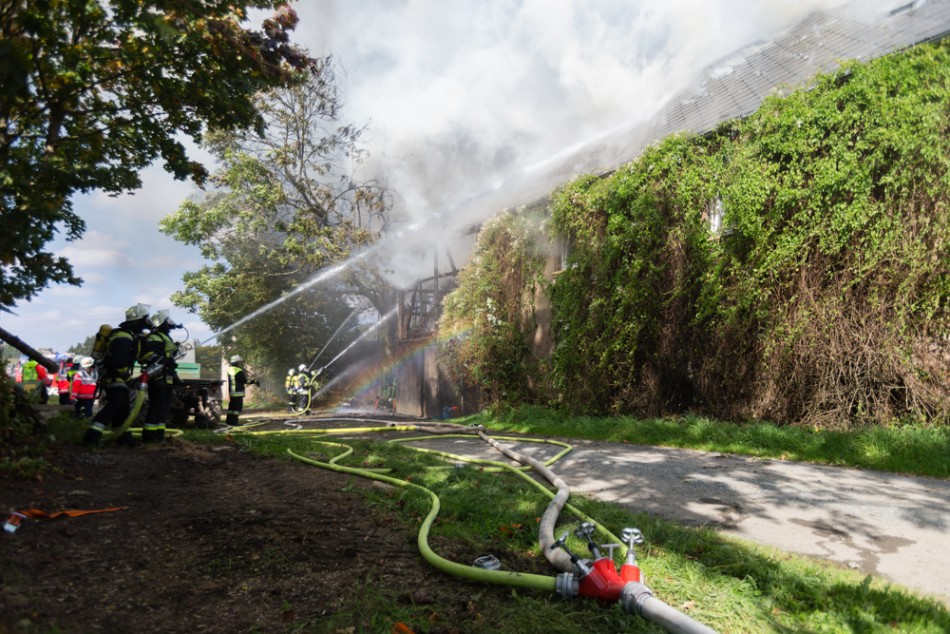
[142, 310, 180, 444]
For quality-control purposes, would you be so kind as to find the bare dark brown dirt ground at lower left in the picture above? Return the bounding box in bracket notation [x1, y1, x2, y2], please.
[0, 438, 501, 634]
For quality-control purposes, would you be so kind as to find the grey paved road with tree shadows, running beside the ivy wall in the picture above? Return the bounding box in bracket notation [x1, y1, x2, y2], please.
[410, 438, 950, 605]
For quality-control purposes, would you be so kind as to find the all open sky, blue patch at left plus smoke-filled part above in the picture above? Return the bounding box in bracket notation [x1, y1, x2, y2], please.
[0, 0, 894, 351]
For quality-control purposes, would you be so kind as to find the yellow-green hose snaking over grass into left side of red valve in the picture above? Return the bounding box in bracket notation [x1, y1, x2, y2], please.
[287, 449, 556, 592]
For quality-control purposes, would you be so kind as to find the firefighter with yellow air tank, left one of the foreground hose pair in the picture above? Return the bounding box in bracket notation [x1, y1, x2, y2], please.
[83, 304, 151, 447]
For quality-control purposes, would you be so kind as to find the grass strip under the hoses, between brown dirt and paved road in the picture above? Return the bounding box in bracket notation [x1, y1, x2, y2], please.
[216, 430, 950, 633]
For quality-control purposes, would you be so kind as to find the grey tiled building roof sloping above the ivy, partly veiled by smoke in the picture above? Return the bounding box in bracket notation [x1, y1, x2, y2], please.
[528, 0, 950, 206]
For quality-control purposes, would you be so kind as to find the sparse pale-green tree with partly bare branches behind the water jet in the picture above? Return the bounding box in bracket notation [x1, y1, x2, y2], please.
[161, 73, 387, 378]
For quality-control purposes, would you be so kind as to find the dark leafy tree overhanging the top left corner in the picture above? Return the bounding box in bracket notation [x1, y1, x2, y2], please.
[0, 0, 314, 307]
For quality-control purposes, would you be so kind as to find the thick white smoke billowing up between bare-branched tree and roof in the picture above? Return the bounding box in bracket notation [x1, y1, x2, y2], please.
[296, 0, 894, 281]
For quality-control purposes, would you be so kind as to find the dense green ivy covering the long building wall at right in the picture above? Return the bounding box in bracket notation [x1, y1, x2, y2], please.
[447, 41, 950, 426]
